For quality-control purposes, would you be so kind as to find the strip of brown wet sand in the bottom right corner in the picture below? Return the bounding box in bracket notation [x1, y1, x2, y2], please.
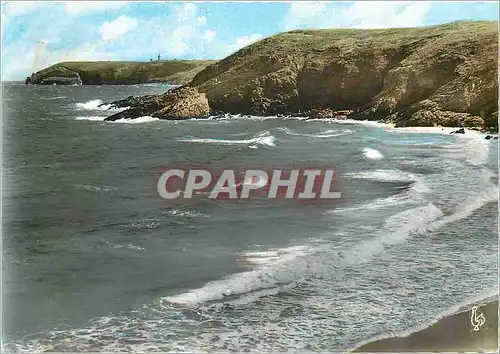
[351, 298, 498, 352]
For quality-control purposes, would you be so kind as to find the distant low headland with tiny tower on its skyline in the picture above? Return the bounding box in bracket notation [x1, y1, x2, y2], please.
[26, 60, 215, 85]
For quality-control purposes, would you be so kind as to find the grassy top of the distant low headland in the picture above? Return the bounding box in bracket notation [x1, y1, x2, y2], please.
[32, 60, 215, 84]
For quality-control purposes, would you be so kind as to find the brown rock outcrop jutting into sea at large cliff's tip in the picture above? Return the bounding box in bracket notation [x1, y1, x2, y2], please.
[105, 86, 210, 121]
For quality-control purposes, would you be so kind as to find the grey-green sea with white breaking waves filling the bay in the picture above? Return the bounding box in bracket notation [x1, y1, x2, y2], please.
[2, 83, 498, 352]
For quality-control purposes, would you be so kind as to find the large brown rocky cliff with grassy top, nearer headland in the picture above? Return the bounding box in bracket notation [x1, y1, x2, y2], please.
[105, 22, 498, 129]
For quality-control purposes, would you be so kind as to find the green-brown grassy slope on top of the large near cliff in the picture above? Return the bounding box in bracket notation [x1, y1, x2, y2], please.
[190, 21, 498, 92]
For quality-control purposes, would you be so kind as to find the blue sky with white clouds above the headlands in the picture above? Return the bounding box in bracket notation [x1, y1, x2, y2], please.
[1, 1, 499, 80]
